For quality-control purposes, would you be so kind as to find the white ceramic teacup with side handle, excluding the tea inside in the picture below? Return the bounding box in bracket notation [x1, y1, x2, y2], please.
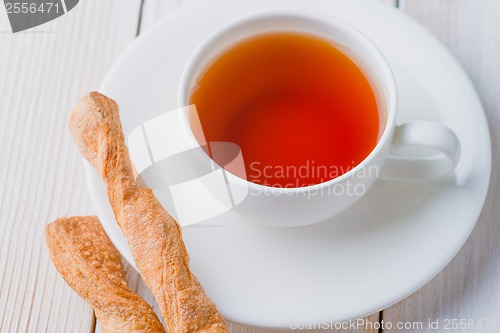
[178, 12, 460, 226]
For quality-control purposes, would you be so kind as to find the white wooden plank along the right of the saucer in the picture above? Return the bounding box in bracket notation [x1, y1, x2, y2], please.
[384, 0, 500, 332]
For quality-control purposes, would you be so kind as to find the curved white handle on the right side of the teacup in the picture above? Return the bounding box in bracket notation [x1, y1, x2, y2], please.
[380, 121, 460, 179]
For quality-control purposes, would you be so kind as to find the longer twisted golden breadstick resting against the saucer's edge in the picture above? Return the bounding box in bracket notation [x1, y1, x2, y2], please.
[70, 92, 229, 333]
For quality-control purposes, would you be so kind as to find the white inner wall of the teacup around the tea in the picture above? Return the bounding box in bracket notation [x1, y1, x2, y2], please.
[178, 12, 396, 189]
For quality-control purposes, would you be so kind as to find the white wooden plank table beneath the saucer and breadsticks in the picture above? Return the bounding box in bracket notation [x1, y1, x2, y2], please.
[0, 0, 500, 333]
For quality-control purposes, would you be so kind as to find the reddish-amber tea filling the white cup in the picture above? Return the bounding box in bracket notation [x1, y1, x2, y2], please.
[189, 33, 381, 187]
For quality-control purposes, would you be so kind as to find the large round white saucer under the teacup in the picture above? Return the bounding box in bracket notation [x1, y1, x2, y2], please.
[86, 0, 491, 328]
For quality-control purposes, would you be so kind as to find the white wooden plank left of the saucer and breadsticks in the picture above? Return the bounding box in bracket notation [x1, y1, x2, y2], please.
[0, 0, 140, 333]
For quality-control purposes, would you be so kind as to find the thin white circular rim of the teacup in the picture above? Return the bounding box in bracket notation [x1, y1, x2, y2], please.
[177, 10, 397, 194]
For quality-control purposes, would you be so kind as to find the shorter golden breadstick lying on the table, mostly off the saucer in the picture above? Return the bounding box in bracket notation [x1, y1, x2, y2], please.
[45, 216, 165, 333]
